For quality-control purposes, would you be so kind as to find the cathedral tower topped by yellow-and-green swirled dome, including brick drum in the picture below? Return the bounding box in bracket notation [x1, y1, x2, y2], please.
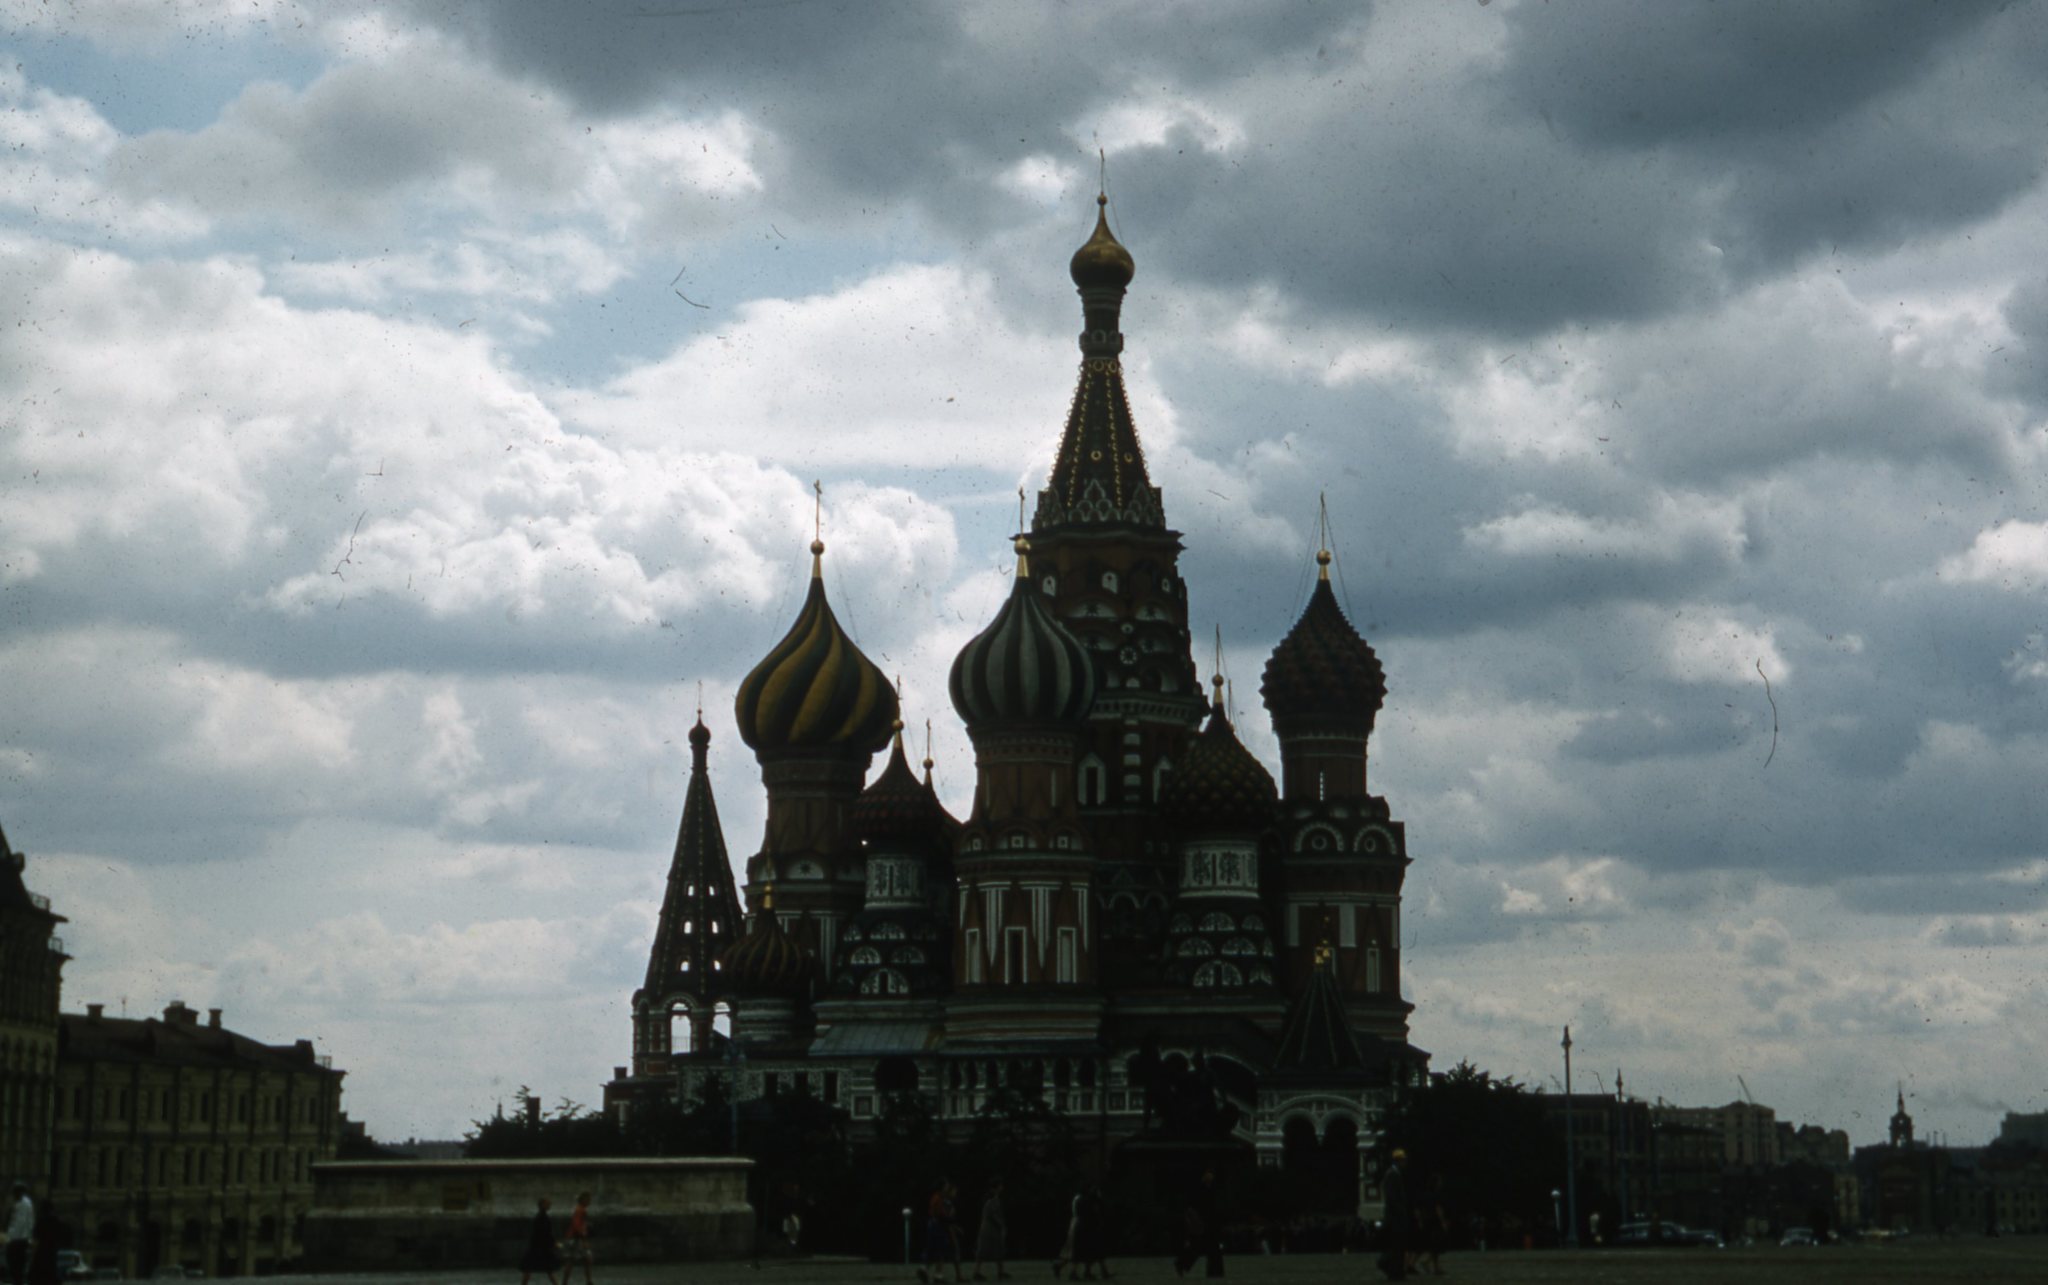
[733, 539, 897, 984]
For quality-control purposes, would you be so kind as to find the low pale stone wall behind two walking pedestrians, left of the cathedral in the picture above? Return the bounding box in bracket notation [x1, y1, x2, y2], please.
[305, 1156, 754, 1271]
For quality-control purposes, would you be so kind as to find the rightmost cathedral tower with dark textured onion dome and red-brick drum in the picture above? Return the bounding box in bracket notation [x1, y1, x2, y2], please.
[1262, 547, 1413, 1039]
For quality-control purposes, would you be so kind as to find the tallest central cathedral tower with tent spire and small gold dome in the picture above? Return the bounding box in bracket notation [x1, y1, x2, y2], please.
[1030, 197, 1208, 978]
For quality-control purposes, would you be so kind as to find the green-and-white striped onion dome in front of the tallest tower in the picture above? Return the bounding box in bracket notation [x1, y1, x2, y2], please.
[948, 537, 1096, 732]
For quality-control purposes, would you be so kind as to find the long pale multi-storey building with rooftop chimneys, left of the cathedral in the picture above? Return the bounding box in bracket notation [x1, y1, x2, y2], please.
[49, 1002, 344, 1277]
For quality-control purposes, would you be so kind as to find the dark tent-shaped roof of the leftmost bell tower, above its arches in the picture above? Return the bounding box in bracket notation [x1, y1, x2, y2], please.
[647, 711, 739, 998]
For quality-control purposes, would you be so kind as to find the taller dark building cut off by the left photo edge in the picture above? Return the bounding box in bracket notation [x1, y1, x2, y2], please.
[0, 830, 68, 1195]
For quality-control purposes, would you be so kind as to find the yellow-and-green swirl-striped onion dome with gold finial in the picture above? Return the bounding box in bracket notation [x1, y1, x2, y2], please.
[733, 541, 897, 754]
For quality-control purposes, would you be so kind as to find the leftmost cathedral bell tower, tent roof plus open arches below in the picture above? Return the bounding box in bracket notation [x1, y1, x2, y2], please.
[633, 711, 739, 1076]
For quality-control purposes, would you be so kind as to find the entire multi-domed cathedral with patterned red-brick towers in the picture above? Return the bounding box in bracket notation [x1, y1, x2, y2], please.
[606, 199, 1427, 1197]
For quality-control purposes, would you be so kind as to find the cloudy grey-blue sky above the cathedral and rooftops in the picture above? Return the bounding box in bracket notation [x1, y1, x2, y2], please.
[0, 0, 2048, 1142]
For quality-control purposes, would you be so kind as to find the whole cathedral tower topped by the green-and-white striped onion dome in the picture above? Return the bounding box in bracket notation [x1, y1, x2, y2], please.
[946, 537, 1102, 1039]
